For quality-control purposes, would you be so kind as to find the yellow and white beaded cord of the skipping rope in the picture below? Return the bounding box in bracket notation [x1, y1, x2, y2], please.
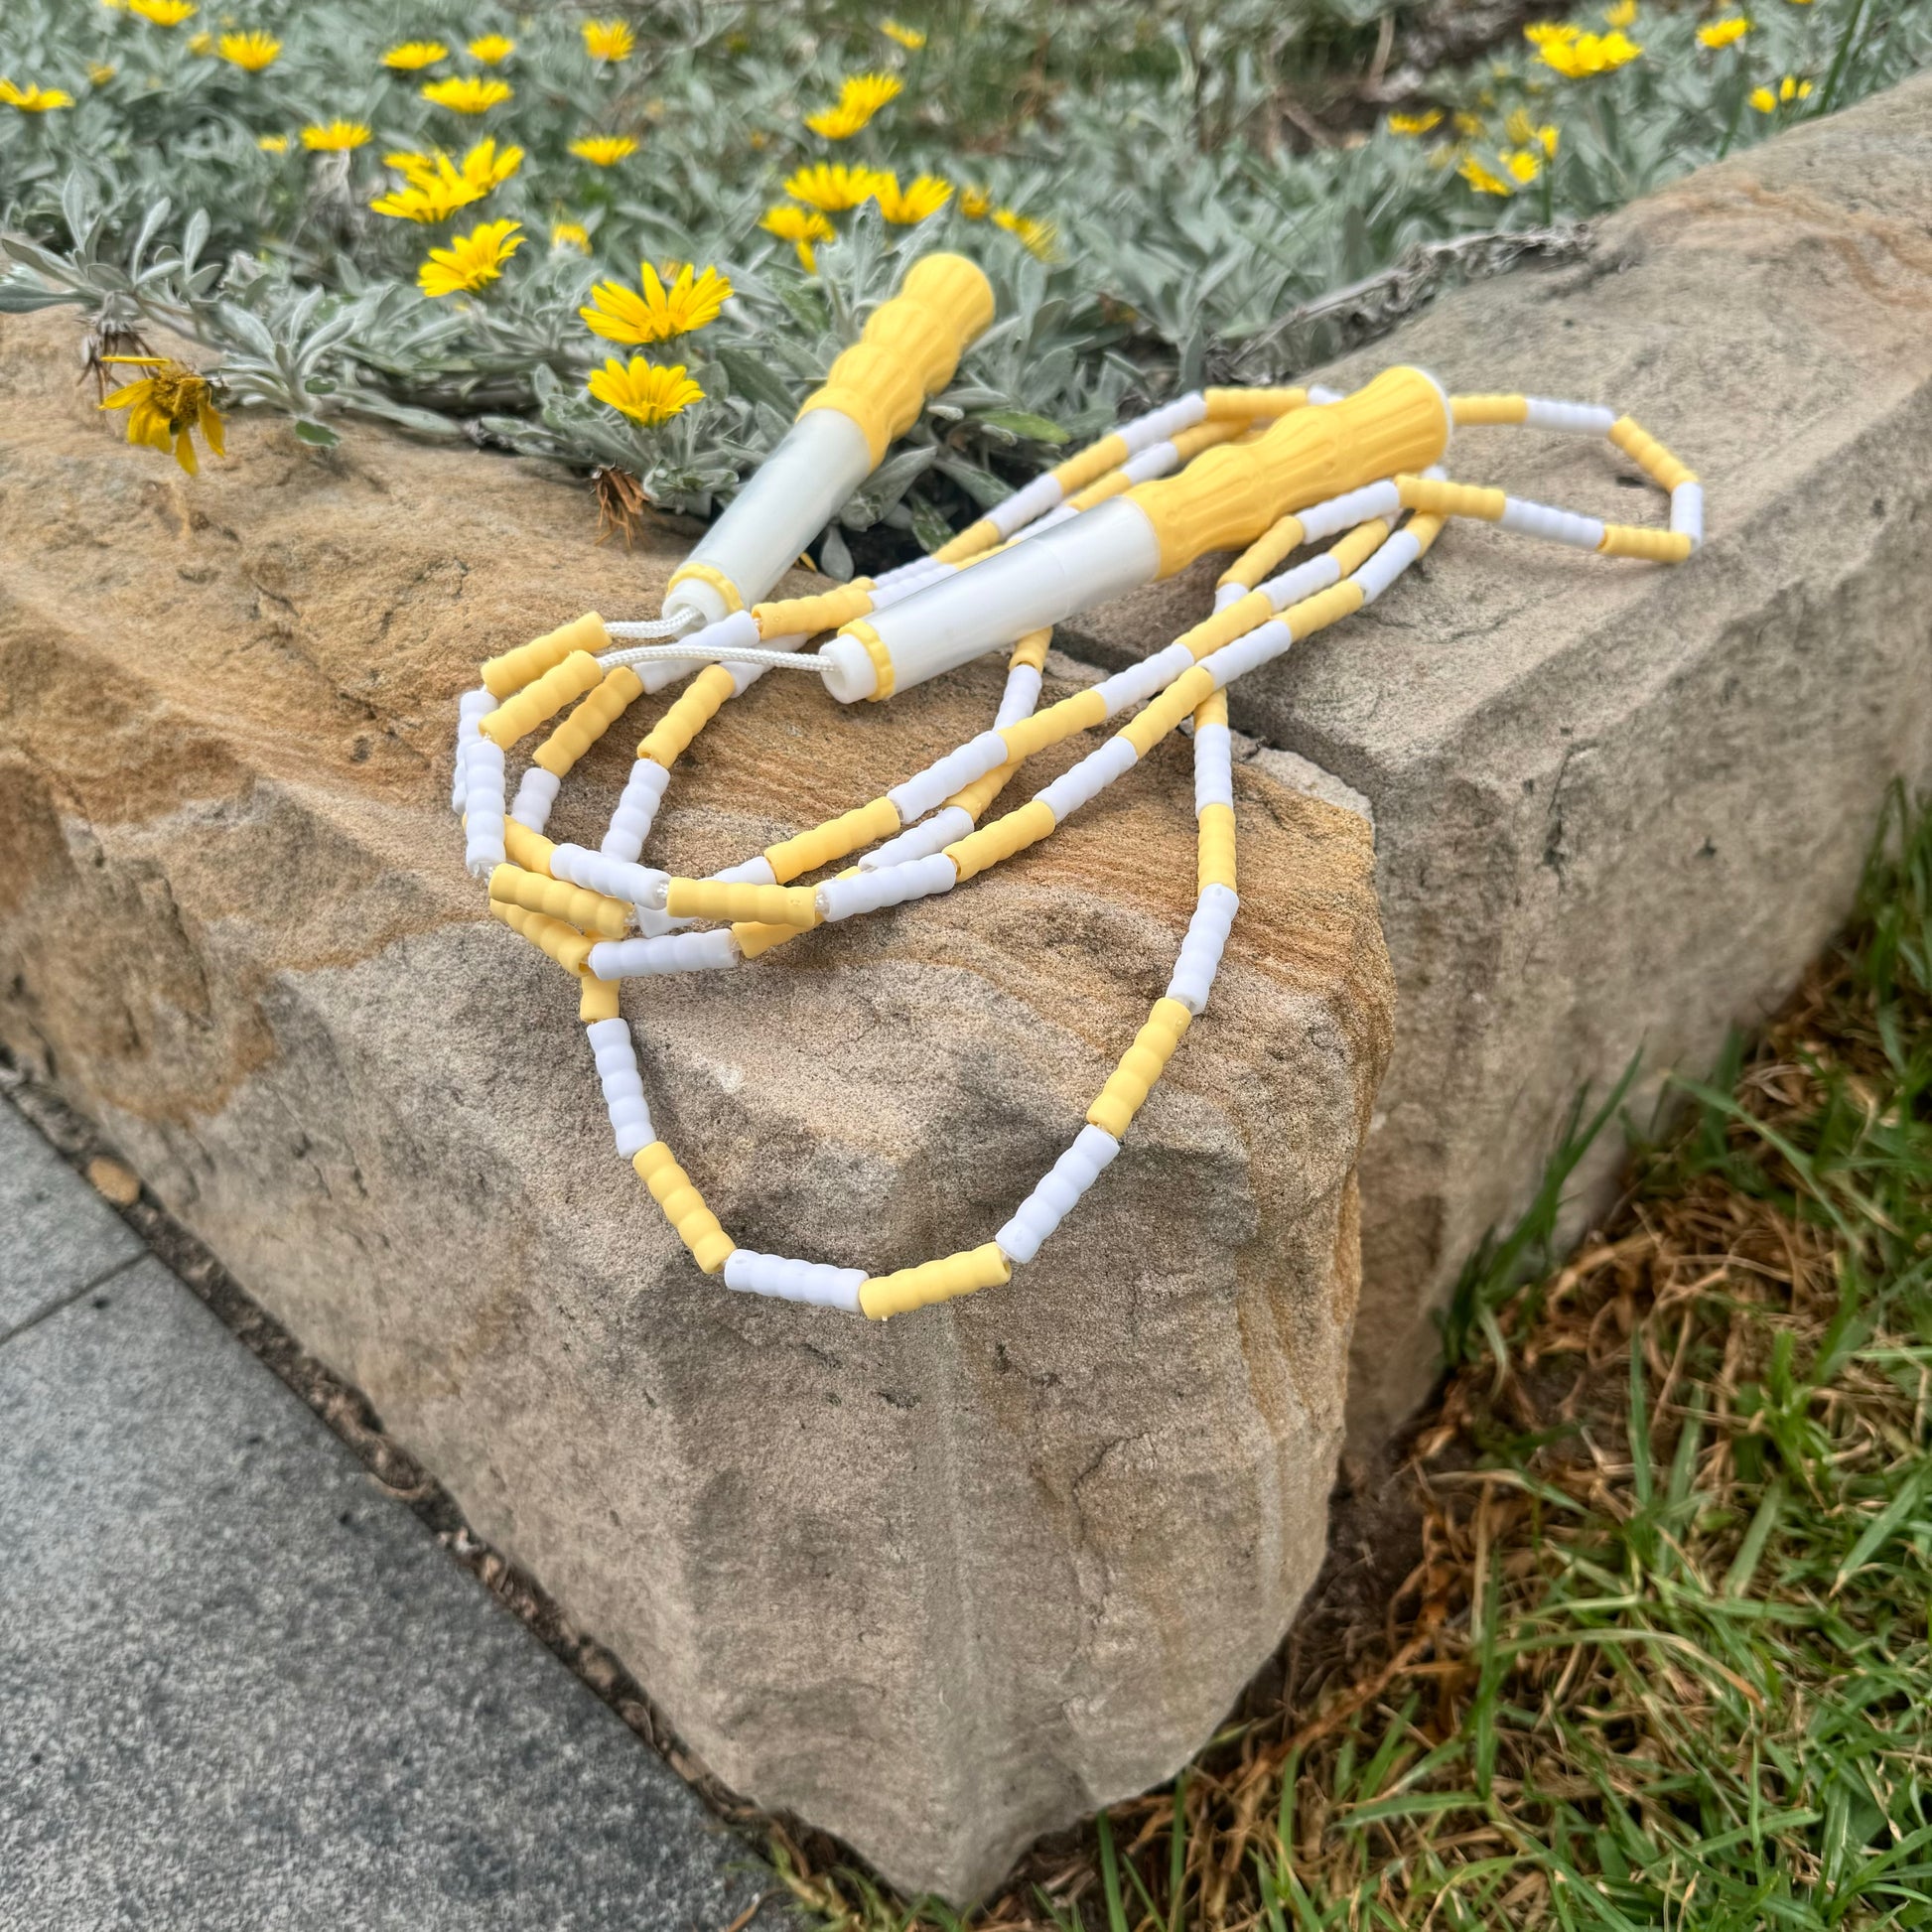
[450, 372, 1704, 1319]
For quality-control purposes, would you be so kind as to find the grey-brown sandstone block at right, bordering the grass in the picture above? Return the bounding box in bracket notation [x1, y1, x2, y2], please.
[1062, 77, 1932, 1444]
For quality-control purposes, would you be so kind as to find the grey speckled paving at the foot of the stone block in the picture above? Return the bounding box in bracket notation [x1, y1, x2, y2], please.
[0, 1101, 788, 1932]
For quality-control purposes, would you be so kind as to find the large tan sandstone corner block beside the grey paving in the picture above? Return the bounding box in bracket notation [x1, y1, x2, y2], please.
[0, 297, 1391, 1897]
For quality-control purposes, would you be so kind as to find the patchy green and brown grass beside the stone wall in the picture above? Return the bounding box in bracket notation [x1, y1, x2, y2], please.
[774, 794, 1932, 1932]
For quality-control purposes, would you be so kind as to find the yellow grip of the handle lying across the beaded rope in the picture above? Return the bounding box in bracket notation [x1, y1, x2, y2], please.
[1127, 369, 1450, 578]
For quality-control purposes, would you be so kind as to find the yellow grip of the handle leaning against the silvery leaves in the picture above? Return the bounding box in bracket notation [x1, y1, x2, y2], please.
[798, 255, 993, 470]
